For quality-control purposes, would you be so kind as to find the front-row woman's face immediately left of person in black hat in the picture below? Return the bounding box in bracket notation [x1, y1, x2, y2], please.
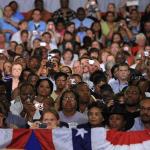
[88, 107, 104, 127]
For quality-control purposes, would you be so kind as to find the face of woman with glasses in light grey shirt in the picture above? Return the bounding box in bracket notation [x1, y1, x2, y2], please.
[62, 92, 77, 112]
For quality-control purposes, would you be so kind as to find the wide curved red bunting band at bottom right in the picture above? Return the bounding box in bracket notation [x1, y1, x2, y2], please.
[106, 130, 150, 145]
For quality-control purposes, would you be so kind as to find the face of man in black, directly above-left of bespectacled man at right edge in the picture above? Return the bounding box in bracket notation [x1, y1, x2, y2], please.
[125, 86, 140, 106]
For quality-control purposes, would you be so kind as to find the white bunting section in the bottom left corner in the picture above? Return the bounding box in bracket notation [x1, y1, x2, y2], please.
[0, 129, 13, 148]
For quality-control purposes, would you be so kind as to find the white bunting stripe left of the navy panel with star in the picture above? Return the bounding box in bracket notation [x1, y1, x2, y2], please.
[52, 128, 73, 150]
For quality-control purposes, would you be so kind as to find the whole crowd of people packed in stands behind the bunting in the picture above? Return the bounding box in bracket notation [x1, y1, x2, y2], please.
[0, 0, 150, 131]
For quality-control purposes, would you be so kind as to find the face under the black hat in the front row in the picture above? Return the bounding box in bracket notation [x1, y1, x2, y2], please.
[109, 114, 125, 130]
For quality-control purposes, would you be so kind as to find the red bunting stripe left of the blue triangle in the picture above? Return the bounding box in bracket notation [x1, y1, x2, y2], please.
[8, 129, 32, 149]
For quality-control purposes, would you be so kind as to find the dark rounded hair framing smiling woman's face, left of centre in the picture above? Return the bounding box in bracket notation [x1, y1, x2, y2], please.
[35, 78, 53, 95]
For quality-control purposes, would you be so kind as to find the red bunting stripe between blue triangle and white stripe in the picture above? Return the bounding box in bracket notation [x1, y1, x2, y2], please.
[34, 129, 55, 150]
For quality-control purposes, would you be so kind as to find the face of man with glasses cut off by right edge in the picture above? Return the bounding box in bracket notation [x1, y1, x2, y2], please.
[140, 99, 150, 123]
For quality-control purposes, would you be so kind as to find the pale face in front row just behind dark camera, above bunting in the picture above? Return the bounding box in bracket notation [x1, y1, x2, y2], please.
[42, 112, 59, 129]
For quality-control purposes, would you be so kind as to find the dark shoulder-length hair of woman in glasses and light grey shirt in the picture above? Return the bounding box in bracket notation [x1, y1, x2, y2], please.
[59, 90, 79, 111]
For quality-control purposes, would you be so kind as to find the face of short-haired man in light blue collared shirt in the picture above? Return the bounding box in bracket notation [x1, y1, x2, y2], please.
[118, 66, 130, 80]
